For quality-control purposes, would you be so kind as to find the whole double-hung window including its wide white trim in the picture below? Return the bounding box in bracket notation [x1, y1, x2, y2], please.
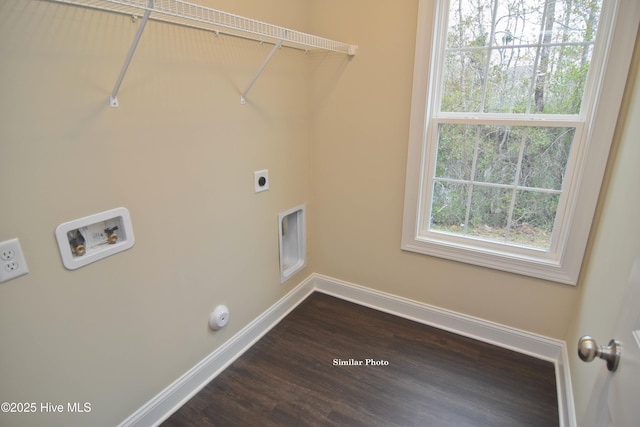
[402, 0, 638, 284]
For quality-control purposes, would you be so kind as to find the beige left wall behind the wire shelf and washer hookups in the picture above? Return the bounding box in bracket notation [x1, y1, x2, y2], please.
[0, 0, 313, 426]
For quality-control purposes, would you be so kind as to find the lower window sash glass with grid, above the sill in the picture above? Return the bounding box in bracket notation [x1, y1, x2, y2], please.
[429, 123, 575, 249]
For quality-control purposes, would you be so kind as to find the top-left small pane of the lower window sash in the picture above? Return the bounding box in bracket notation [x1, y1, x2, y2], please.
[435, 124, 477, 180]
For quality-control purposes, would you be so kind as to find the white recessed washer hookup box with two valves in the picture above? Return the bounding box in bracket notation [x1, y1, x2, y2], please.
[56, 208, 134, 270]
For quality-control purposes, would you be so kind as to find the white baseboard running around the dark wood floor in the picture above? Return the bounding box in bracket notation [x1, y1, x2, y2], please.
[120, 273, 576, 427]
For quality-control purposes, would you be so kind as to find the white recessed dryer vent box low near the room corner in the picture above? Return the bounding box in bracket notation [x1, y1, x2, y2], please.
[278, 205, 307, 283]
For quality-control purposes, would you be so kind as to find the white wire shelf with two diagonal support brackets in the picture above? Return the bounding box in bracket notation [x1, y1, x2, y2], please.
[43, 0, 357, 107]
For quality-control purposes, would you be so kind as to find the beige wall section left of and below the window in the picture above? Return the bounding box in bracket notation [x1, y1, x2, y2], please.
[311, 0, 577, 338]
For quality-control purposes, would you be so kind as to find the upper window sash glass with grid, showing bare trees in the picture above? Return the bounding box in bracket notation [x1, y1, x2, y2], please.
[440, 0, 602, 114]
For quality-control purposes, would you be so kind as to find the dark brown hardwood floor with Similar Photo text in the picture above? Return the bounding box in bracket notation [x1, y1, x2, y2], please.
[162, 293, 559, 427]
